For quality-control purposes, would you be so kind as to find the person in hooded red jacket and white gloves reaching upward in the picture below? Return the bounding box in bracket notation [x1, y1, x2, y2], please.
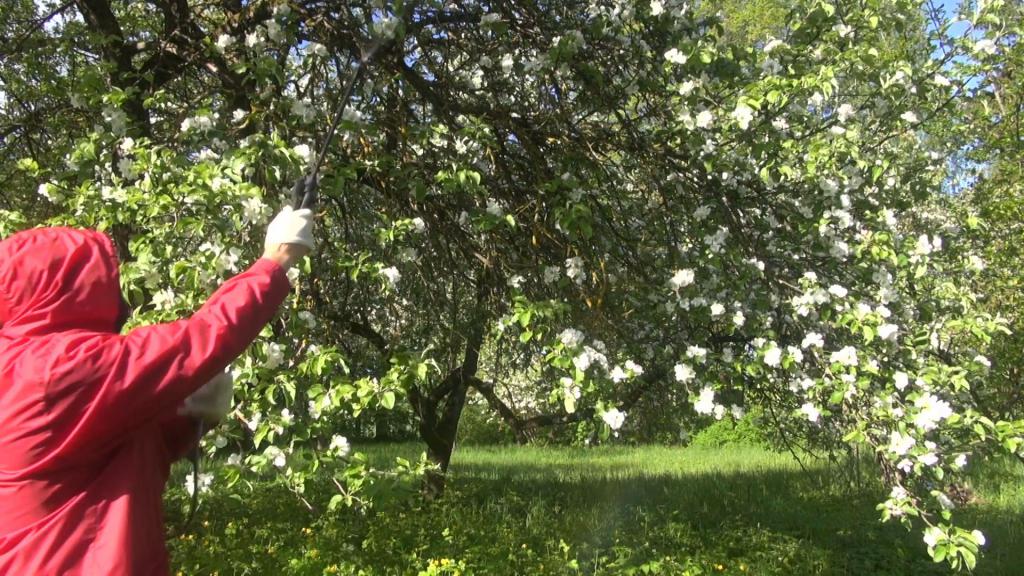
[0, 203, 313, 576]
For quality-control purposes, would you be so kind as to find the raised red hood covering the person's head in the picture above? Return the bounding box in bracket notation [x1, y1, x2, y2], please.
[0, 228, 127, 337]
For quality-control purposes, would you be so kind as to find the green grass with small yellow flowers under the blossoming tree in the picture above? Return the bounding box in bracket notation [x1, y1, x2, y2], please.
[168, 445, 1024, 576]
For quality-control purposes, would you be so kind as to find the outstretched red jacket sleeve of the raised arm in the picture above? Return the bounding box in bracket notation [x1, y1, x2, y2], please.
[63, 258, 290, 445]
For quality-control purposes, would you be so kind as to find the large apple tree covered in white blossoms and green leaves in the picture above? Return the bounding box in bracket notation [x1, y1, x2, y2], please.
[0, 0, 1024, 567]
